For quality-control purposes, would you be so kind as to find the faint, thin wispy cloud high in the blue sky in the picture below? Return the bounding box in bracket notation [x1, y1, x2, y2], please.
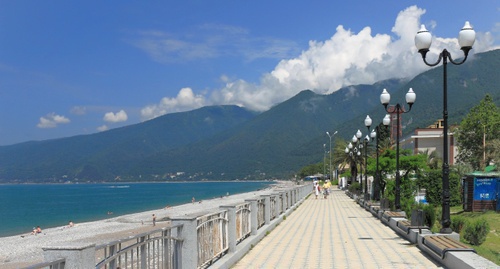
[130, 24, 298, 63]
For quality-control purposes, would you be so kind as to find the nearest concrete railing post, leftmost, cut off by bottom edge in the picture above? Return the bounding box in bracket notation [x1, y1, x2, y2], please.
[42, 243, 95, 269]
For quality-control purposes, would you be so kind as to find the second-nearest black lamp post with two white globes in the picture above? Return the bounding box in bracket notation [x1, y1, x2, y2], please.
[380, 88, 417, 211]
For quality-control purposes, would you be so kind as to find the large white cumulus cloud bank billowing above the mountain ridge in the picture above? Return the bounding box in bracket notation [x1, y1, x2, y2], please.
[142, 6, 493, 118]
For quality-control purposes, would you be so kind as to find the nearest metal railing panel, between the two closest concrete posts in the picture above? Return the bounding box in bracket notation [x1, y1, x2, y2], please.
[95, 227, 182, 269]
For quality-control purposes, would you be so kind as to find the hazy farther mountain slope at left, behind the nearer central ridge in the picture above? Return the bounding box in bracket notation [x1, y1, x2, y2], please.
[0, 106, 255, 182]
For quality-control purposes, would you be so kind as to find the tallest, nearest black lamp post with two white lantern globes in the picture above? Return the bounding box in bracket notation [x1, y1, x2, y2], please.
[415, 21, 476, 231]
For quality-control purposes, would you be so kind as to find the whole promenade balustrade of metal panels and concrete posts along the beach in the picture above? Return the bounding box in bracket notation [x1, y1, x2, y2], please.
[26, 184, 311, 269]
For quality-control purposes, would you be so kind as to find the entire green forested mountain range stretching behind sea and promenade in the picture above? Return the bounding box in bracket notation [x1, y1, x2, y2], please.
[0, 50, 500, 182]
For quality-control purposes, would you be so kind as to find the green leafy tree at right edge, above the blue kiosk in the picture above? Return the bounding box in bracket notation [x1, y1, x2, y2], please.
[457, 95, 500, 170]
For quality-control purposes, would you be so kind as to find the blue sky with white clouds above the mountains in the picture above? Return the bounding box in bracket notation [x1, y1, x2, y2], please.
[0, 0, 500, 145]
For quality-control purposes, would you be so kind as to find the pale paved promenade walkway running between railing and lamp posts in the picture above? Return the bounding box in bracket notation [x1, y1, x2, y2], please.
[232, 189, 443, 269]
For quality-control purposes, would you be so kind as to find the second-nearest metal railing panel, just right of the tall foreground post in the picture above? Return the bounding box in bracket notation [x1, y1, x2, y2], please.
[196, 211, 229, 268]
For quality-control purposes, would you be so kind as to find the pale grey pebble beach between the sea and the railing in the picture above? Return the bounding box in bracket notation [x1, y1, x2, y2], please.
[0, 181, 295, 269]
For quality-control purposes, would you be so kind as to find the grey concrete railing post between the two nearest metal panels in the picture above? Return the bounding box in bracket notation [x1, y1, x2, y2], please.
[171, 216, 198, 268]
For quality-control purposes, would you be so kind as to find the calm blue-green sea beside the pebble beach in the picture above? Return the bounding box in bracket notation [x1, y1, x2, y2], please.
[0, 182, 272, 237]
